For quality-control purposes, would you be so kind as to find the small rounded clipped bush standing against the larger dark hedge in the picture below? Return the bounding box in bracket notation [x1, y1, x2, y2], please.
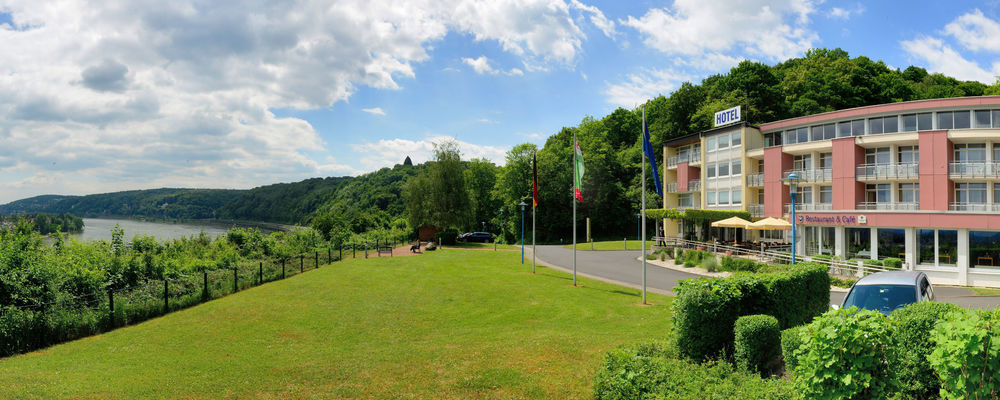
[733, 314, 781, 377]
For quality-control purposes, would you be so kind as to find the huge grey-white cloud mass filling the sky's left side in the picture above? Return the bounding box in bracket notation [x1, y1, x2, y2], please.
[0, 0, 614, 201]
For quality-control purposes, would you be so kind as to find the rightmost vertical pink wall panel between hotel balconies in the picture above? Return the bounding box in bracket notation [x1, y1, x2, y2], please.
[918, 131, 955, 211]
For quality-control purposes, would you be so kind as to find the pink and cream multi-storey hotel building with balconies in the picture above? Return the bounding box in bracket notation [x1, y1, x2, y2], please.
[663, 96, 1000, 286]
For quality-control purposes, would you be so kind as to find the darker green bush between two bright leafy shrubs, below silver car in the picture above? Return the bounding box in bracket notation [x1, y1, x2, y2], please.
[889, 301, 962, 399]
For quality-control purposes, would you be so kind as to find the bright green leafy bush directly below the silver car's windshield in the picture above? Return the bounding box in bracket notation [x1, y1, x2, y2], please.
[794, 307, 895, 399]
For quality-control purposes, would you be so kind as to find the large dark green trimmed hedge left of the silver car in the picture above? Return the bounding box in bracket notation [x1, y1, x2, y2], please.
[673, 263, 830, 360]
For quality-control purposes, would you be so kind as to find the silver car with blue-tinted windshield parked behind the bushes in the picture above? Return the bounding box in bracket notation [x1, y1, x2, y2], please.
[834, 271, 934, 315]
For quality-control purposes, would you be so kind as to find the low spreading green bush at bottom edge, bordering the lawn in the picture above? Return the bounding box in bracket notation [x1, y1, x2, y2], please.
[594, 345, 796, 400]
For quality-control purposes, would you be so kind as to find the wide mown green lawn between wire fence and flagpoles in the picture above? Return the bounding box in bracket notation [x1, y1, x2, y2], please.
[0, 249, 670, 399]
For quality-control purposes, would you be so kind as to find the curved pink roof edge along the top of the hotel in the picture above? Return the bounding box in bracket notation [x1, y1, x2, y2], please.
[760, 96, 1000, 131]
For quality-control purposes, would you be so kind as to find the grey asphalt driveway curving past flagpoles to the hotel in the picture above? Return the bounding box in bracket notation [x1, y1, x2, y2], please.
[537, 245, 1000, 309]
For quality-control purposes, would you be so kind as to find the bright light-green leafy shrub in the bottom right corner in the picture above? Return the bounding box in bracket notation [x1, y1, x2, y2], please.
[927, 310, 1000, 399]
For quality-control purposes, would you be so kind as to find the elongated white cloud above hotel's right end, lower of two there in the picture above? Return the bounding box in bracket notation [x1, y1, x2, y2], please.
[901, 36, 998, 84]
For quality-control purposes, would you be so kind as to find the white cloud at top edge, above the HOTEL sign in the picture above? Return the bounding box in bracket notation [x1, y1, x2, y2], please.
[619, 0, 818, 61]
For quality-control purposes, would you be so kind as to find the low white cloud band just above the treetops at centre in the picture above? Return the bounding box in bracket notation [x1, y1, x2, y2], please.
[351, 136, 508, 169]
